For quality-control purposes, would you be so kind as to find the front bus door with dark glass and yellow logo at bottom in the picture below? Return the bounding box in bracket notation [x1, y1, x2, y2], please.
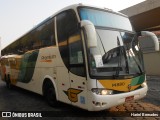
[68, 33, 87, 108]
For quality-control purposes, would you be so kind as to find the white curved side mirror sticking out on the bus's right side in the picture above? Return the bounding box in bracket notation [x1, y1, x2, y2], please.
[138, 31, 159, 52]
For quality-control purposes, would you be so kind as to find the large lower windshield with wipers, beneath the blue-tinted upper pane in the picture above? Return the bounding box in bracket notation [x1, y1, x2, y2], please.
[88, 29, 144, 77]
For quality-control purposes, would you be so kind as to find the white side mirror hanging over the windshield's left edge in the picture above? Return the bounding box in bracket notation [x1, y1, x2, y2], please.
[80, 20, 97, 48]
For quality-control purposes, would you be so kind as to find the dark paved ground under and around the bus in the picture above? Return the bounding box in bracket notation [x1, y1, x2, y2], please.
[0, 77, 160, 120]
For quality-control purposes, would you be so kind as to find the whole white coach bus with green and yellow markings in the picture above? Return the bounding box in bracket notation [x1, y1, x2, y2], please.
[1, 4, 148, 111]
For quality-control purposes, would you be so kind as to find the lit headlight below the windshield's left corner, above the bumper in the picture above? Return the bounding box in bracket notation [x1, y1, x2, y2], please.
[91, 88, 113, 95]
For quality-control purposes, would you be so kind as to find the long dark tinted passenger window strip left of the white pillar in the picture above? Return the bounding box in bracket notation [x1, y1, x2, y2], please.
[15, 18, 56, 54]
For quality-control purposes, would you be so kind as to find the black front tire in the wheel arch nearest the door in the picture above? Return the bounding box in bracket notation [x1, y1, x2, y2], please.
[44, 83, 57, 107]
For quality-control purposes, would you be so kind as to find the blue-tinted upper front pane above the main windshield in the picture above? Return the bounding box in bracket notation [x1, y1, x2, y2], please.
[79, 7, 132, 31]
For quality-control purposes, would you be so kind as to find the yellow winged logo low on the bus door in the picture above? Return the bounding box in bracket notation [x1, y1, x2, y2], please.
[64, 88, 82, 102]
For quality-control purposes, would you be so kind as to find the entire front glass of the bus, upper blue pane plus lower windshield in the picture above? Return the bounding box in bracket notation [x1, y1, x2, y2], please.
[80, 8, 144, 78]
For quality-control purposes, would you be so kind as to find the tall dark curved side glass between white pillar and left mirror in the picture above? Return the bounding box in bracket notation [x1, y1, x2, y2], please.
[57, 10, 85, 76]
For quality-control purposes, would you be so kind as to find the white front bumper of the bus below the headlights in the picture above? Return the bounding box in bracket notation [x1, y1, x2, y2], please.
[88, 83, 148, 111]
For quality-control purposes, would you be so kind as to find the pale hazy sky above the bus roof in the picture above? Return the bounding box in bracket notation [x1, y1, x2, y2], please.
[0, 0, 145, 49]
